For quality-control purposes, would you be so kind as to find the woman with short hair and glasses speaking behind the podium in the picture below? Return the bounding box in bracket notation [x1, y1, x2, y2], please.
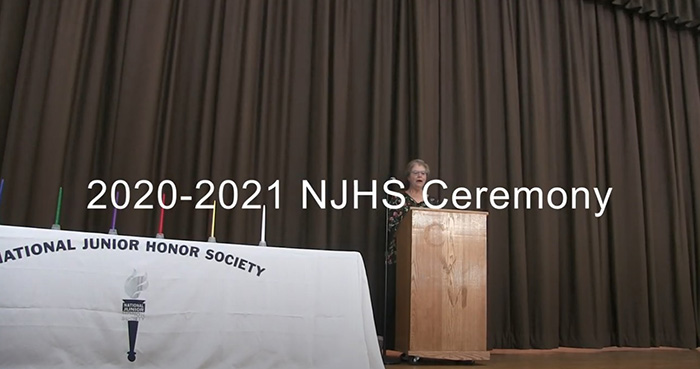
[384, 159, 437, 354]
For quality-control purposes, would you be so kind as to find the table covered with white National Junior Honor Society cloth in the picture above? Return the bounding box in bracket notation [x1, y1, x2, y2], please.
[0, 226, 384, 369]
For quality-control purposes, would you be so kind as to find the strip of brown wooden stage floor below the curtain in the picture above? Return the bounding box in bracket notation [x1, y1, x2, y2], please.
[386, 348, 700, 369]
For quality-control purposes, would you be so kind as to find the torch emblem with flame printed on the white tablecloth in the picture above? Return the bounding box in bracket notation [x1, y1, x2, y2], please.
[122, 269, 148, 362]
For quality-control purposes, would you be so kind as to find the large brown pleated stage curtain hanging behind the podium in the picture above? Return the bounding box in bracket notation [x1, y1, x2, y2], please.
[0, 0, 700, 348]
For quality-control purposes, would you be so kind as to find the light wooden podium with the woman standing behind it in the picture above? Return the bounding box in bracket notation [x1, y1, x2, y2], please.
[396, 208, 490, 360]
